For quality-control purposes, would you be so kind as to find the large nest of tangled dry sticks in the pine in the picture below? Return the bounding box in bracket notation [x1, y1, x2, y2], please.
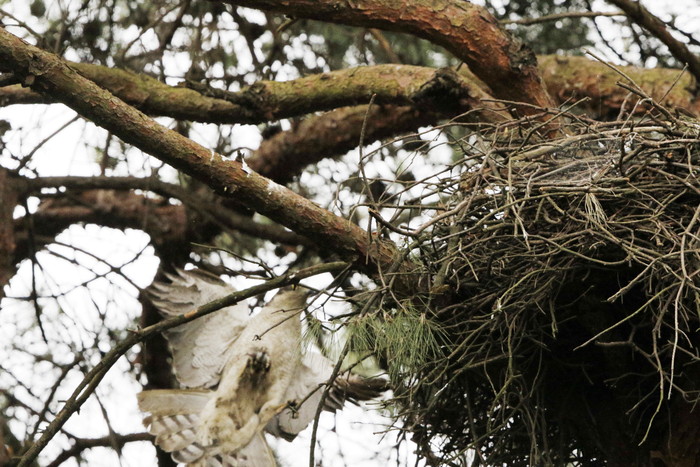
[352, 116, 700, 465]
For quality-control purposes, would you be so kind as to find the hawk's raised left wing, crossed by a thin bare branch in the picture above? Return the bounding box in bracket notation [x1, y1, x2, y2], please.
[149, 270, 248, 388]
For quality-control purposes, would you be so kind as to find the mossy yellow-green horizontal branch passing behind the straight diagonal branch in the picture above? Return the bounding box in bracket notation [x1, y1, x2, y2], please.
[0, 62, 492, 123]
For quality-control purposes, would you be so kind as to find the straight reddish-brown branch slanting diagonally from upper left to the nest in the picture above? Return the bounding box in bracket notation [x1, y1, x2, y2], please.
[0, 28, 396, 272]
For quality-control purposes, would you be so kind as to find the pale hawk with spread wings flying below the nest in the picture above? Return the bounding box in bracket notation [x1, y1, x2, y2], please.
[138, 270, 386, 467]
